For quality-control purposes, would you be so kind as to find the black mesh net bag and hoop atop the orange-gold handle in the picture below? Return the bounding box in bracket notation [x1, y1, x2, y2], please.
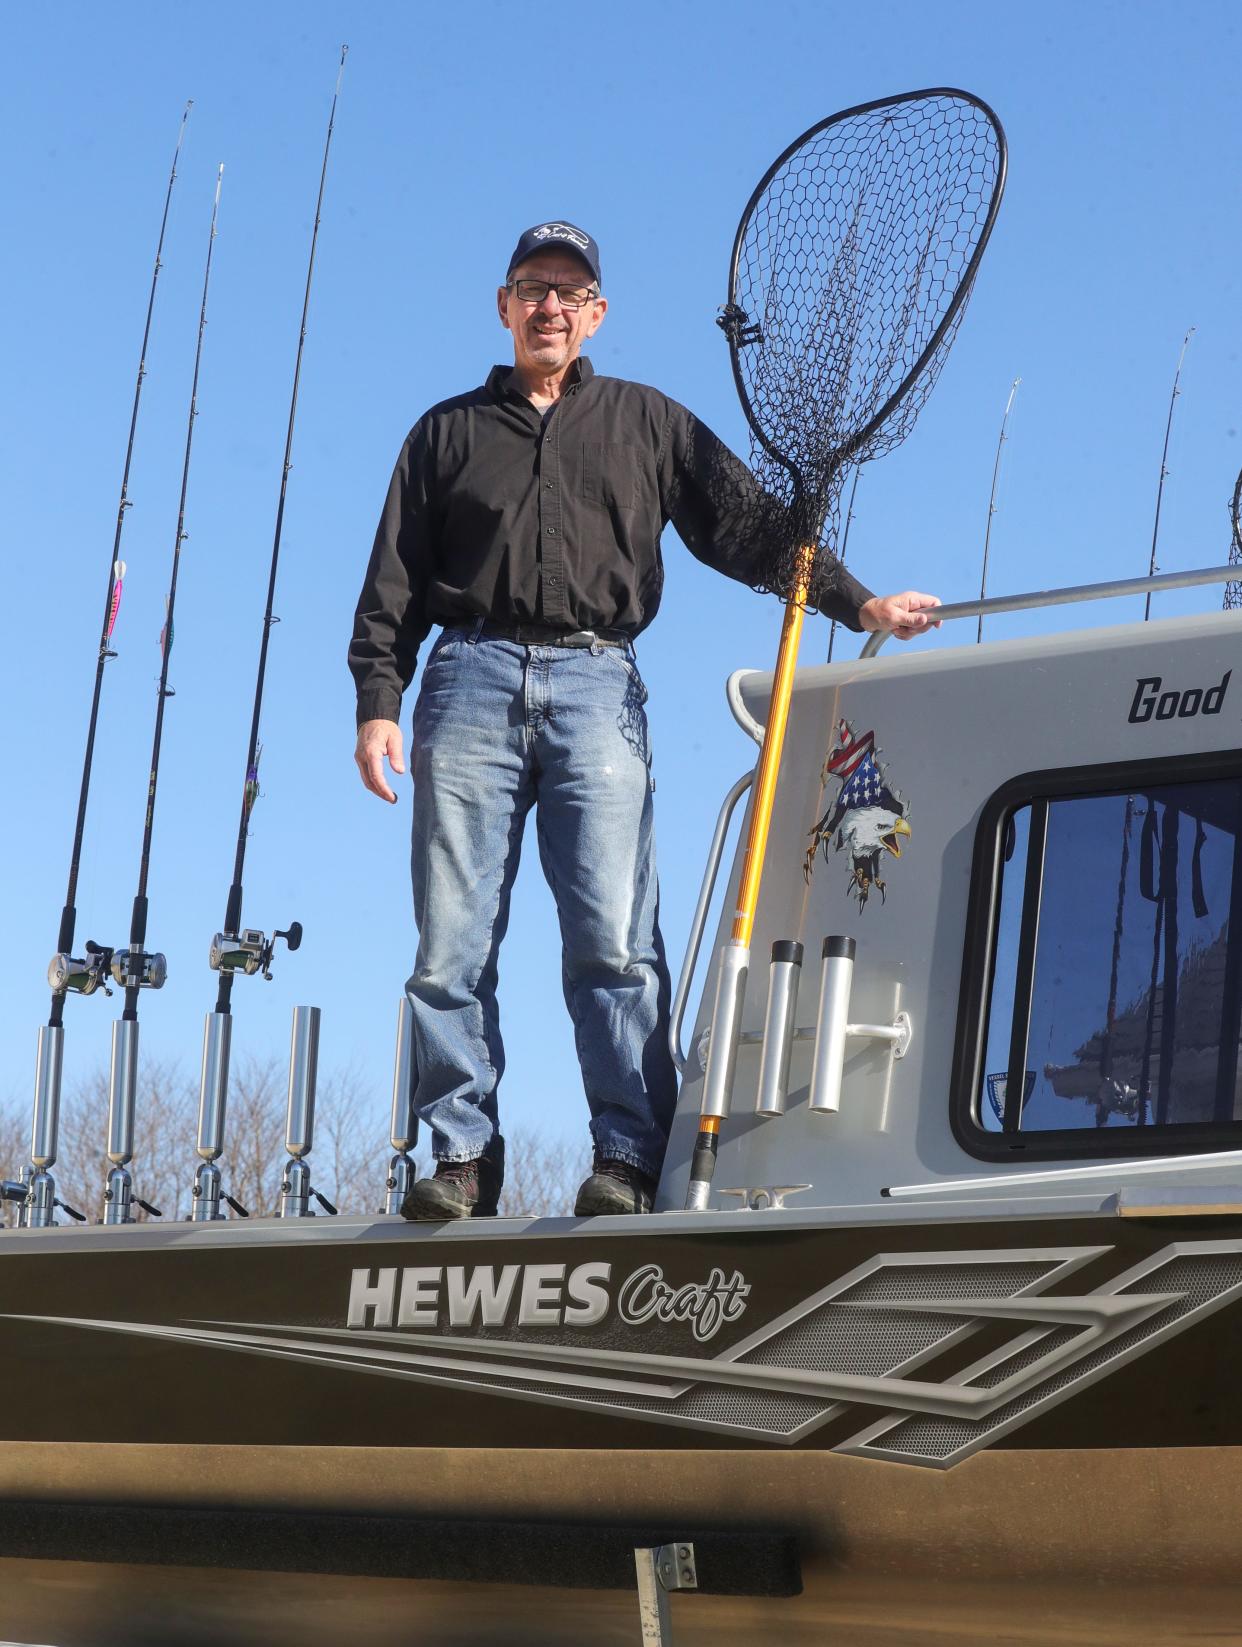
[720, 91, 1005, 604]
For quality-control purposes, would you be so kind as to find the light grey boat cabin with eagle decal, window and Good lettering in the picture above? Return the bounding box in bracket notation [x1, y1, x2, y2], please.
[659, 586, 1242, 1217]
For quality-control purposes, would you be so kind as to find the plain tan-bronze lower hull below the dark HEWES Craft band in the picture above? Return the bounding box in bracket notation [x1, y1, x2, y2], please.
[0, 1443, 1242, 1647]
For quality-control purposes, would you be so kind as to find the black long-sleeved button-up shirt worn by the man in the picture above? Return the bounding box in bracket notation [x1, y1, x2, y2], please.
[349, 357, 870, 725]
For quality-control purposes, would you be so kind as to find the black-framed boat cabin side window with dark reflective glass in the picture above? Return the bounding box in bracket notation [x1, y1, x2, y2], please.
[955, 763, 1242, 1156]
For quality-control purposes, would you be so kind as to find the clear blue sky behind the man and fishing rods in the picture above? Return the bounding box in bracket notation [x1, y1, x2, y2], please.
[0, 0, 1242, 1169]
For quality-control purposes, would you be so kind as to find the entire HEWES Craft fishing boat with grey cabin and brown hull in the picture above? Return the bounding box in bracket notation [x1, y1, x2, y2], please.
[0, 568, 1242, 1647]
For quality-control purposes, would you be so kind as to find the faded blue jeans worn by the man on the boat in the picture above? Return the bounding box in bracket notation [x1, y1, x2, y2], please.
[405, 629, 677, 1178]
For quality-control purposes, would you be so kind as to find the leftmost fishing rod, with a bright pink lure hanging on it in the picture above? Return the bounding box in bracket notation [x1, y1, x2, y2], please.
[26, 99, 193, 1222]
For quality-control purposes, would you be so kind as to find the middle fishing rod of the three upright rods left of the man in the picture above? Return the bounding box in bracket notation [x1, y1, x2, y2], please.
[90, 166, 224, 1224]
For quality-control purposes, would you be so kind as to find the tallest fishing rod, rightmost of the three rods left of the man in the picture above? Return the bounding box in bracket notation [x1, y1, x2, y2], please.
[189, 46, 349, 1222]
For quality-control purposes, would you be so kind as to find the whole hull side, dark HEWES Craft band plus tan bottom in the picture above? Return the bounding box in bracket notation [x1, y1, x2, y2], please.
[0, 1211, 1242, 1647]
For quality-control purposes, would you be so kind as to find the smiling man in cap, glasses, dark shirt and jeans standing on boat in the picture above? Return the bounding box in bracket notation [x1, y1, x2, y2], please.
[349, 221, 937, 1219]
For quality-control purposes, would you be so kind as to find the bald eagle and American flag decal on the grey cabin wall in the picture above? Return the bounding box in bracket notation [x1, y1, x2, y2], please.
[802, 720, 909, 909]
